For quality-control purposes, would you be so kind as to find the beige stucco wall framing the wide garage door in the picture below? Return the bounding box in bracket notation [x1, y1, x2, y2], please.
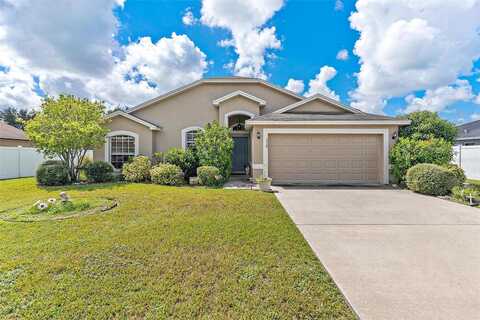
[250, 124, 398, 178]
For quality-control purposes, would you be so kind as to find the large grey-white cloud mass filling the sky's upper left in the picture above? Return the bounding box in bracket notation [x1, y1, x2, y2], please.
[0, 0, 208, 108]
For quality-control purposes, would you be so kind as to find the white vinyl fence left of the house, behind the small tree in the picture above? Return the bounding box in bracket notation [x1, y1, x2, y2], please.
[0, 147, 93, 179]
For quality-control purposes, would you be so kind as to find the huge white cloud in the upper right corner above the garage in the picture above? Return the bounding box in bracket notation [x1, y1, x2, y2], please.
[350, 0, 480, 112]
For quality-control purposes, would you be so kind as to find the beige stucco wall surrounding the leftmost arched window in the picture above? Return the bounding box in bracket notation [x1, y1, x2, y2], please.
[93, 116, 156, 160]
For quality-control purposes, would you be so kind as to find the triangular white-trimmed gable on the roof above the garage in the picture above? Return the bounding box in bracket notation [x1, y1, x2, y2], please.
[274, 94, 361, 114]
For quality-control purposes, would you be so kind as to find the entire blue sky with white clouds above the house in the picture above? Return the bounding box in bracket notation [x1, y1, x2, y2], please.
[0, 0, 480, 123]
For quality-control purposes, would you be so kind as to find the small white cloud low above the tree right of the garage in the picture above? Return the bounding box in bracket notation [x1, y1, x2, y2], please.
[405, 80, 474, 113]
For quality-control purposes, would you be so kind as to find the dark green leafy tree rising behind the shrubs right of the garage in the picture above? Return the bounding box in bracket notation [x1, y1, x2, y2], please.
[399, 111, 457, 143]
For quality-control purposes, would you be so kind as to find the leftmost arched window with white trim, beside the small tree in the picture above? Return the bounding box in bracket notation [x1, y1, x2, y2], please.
[105, 131, 138, 169]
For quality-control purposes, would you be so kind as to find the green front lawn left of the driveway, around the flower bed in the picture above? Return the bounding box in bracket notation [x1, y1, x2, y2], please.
[0, 179, 355, 319]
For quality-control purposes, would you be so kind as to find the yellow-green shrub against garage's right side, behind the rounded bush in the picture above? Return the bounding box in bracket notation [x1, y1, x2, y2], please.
[390, 138, 453, 183]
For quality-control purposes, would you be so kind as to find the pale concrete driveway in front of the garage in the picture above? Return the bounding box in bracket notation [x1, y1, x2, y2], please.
[277, 187, 480, 319]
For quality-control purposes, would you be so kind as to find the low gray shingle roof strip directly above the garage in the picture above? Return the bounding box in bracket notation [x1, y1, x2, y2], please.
[252, 113, 398, 122]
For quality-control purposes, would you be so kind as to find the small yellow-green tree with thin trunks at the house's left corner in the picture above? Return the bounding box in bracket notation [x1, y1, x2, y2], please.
[26, 95, 108, 182]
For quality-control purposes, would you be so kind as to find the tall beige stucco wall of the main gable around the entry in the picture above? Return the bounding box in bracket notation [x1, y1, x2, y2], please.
[131, 83, 299, 152]
